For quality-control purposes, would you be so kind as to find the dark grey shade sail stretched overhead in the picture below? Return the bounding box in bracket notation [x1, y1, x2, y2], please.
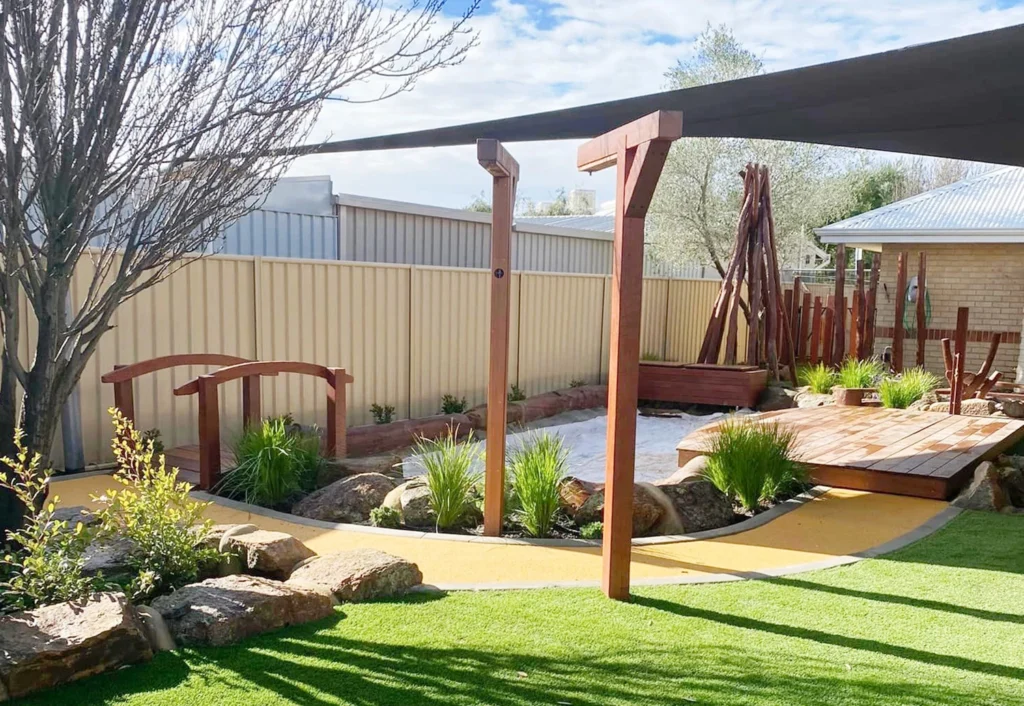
[288, 25, 1024, 166]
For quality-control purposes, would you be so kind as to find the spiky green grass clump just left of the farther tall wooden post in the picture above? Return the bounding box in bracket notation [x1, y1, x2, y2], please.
[416, 427, 480, 530]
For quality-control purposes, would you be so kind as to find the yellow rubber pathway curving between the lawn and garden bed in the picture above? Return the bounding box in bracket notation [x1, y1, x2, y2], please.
[52, 475, 947, 588]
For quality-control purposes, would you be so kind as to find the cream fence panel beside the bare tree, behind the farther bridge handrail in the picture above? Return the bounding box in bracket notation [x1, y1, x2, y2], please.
[73, 257, 256, 463]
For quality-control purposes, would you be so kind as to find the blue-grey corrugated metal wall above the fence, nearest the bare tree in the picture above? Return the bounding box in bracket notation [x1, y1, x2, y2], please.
[219, 209, 338, 260]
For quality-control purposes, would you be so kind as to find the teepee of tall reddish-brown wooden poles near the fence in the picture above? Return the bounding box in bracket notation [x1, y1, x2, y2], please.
[697, 164, 797, 382]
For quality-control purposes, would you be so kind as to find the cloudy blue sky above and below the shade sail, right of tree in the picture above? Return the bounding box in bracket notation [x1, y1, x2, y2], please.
[288, 0, 1024, 208]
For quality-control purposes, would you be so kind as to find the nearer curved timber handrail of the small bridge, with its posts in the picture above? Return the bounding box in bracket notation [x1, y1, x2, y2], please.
[180, 361, 354, 490]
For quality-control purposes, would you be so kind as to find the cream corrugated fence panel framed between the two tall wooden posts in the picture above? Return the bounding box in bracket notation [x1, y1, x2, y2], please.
[519, 274, 605, 394]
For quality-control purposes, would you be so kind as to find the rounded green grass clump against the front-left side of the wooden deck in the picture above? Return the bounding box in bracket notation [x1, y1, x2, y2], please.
[705, 417, 807, 510]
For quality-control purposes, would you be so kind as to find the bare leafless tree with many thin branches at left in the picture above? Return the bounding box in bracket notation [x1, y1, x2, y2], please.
[0, 0, 476, 525]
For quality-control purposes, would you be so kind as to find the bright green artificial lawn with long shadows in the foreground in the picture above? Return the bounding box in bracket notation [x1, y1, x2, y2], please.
[19, 513, 1024, 706]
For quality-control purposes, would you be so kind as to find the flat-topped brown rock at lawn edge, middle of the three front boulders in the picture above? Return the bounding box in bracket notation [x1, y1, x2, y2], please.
[153, 576, 334, 645]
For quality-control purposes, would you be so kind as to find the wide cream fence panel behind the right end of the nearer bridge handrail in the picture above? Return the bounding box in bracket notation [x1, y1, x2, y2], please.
[259, 259, 411, 425]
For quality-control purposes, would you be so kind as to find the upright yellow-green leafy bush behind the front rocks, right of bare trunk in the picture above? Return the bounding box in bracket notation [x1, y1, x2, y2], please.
[93, 408, 220, 601]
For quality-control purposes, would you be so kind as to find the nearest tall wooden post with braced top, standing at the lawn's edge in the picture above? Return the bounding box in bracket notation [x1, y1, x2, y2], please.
[577, 111, 683, 600]
